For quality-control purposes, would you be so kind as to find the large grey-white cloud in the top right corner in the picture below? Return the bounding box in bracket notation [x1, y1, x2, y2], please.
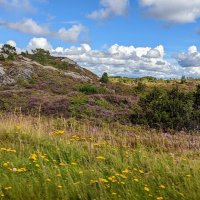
[139, 0, 200, 23]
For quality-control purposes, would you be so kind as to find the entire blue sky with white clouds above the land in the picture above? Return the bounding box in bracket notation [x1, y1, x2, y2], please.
[0, 0, 200, 79]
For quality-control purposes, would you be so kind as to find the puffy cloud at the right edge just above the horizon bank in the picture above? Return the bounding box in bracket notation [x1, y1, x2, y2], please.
[175, 46, 200, 67]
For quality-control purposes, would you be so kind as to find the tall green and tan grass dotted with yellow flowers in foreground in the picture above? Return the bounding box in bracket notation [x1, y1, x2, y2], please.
[0, 115, 200, 200]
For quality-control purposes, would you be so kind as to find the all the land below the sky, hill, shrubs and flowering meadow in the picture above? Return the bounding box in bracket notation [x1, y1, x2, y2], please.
[0, 45, 200, 200]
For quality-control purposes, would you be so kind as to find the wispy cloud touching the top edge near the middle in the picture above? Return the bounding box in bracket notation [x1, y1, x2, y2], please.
[87, 0, 129, 20]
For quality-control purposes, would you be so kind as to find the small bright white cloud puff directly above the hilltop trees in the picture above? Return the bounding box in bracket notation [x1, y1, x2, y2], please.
[27, 38, 52, 51]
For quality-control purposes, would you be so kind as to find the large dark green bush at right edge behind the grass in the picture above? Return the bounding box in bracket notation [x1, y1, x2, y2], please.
[132, 88, 200, 130]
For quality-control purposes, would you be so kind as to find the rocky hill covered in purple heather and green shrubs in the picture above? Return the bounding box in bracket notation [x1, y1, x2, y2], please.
[0, 50, 136, 121]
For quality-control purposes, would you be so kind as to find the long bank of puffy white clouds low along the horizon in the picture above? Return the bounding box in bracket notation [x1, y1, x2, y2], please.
[0, 38, 200, 78]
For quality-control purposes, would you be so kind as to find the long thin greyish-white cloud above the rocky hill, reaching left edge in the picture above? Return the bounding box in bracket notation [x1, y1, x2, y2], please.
[0, 19, 86, 43]
